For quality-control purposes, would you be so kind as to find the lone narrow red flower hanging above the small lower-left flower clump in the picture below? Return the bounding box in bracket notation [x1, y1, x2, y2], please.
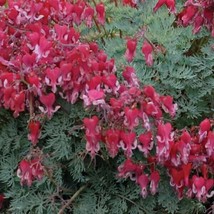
[28, 121, 41, 146]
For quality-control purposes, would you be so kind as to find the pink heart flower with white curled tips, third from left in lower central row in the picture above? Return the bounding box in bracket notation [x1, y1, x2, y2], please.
[119, 131, 137, 157]
